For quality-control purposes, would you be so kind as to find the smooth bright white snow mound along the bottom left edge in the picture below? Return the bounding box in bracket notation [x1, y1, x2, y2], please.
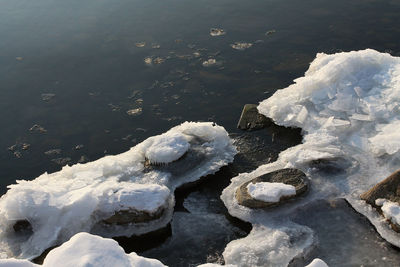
[0, 233, 166, 267]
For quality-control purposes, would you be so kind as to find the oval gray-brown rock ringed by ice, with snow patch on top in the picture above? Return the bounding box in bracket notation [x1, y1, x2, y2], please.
[235, 169, 308, 209]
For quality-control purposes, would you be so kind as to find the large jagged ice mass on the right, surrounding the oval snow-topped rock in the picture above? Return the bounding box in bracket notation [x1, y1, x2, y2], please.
[221, 49, 400, 266]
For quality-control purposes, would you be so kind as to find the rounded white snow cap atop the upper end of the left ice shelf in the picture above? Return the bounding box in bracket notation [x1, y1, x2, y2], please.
[144, 133, 190, 164]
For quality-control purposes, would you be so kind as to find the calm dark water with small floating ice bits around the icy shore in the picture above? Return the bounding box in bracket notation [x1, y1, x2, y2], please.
[0, 0, 400, 266]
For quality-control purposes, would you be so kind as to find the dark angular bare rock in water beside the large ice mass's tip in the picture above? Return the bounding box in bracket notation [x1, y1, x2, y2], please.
[237, 104, 271, 130]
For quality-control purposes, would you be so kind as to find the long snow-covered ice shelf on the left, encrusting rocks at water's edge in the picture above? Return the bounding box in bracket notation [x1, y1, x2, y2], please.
[0, 122, 236, 258]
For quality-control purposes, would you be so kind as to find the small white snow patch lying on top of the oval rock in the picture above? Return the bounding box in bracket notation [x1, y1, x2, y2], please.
[247, 182, 296, 202]
